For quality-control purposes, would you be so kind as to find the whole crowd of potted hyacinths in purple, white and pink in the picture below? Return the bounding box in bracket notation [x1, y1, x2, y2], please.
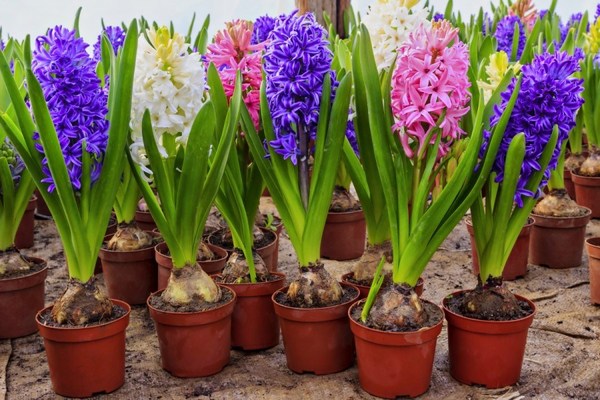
[0, 0, 600, 398]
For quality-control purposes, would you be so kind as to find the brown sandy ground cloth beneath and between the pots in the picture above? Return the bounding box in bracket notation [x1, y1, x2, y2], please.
[0, 200, 600, 400]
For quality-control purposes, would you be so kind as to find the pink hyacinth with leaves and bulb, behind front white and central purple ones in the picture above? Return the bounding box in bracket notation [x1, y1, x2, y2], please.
[205, 17, 269, 282]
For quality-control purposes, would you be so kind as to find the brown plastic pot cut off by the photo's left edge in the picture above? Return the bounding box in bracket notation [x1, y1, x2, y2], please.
[0, 257, 48, 339]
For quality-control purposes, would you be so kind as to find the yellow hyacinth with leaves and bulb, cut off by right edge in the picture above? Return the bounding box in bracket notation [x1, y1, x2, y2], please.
[577, 18, 600, 177]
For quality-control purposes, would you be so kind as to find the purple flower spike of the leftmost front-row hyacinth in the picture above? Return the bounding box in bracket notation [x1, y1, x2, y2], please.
[32, 26, 109, 192]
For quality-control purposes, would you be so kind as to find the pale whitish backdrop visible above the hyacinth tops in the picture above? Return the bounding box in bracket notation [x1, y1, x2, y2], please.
[0, 0, 598, 43]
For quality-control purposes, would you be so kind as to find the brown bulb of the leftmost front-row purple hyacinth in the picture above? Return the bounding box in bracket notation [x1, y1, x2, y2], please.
[52, 278, 113, 325]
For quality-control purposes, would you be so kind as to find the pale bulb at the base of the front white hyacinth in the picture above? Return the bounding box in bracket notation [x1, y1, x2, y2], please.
[162, 264, 221, 307]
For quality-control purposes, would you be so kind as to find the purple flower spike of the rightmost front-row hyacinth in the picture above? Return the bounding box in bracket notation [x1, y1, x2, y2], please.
[481, 50, 583, 207]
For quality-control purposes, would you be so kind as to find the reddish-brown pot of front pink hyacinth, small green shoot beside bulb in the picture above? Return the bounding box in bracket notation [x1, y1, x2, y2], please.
[348, 300, 444, 399]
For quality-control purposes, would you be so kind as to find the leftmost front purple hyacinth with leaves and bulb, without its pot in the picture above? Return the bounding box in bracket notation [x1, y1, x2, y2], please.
[0, 21, 137, 325]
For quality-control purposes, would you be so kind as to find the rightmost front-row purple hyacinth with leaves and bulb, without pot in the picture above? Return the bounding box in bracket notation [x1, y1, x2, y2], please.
[464, 52, 583, 317]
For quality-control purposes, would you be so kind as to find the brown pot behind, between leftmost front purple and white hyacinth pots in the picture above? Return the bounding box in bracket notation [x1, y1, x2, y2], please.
[98, 233, 159, 305]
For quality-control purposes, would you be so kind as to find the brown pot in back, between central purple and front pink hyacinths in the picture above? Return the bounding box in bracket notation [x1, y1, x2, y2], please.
[321, 210, 367, 261]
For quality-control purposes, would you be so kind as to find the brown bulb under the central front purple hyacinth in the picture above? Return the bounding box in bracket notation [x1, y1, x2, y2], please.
[287, 264, 344, 307]
